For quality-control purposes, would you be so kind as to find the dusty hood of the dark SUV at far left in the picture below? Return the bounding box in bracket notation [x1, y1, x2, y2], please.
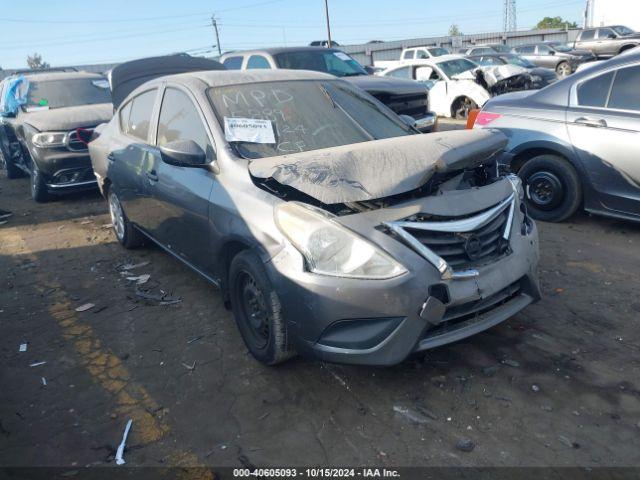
[20, 103, 113, 132]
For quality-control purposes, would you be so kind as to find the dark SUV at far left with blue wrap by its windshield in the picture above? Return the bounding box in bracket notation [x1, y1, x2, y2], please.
[0, 71, 113, 202]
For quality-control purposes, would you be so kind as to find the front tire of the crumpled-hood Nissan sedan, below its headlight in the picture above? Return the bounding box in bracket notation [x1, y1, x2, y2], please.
[229, 250, 296, 365]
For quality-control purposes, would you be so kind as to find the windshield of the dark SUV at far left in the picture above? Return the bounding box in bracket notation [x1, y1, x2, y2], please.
[24, 78, 111, 109]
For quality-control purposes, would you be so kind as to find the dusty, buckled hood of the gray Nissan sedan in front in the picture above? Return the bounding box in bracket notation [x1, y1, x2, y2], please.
[249, 129, 507, 204]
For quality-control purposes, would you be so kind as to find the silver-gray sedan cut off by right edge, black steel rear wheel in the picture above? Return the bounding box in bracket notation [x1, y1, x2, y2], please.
[475, 52, 640, 221]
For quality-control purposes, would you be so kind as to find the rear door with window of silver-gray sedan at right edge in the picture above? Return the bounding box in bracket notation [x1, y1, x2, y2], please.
[567, 64, 640, 215]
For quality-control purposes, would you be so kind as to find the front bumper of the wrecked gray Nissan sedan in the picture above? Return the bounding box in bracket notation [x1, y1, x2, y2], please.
[267, 182, 540, 365]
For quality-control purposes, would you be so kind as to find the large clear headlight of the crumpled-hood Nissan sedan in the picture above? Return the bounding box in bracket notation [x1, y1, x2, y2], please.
[274, 202, 407, 279]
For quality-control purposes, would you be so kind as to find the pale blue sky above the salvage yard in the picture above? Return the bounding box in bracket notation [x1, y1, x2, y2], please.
[0, 0, 588, 68]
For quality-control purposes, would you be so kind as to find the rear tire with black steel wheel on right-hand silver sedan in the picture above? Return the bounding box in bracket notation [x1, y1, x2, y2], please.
[518, 155, 582, 222]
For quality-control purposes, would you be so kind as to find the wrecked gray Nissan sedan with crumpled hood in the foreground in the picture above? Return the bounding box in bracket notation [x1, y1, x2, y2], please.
[90, 70, 540, 365]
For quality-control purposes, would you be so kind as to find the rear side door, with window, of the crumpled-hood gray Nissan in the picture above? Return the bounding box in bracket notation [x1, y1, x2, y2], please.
[107, 88, 158, 228]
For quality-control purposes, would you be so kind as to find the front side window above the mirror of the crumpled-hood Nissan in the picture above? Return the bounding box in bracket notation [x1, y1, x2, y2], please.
[157, 88, 213, 159]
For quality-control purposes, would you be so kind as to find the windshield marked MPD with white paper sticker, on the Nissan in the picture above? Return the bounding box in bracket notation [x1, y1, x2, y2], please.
[207, 80, 417, 158]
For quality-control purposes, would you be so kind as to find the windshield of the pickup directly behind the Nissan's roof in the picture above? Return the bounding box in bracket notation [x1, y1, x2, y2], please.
[274, 49, 367, 77]
